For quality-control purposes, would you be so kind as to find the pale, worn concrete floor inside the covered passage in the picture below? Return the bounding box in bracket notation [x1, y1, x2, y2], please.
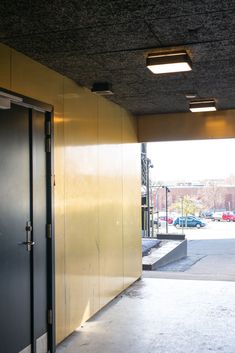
[57, 278, 235, 353]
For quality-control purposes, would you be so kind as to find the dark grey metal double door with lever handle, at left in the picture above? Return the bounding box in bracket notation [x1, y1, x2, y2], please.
[0, 105, 47, 353]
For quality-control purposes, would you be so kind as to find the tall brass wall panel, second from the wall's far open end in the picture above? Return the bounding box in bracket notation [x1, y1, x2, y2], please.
[98, 98, 123, 307]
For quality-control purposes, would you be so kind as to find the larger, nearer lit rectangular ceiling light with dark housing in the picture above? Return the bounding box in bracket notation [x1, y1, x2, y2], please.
[146, 51, 192, 74]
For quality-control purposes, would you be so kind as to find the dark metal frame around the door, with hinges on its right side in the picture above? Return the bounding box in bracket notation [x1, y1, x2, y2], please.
[0, 87, 56, 353]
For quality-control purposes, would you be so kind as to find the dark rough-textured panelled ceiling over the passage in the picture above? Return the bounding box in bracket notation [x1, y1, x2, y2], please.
[0, 0, 235, 114]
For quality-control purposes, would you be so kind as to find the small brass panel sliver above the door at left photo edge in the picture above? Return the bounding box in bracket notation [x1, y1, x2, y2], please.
[0, 43, 11, 89]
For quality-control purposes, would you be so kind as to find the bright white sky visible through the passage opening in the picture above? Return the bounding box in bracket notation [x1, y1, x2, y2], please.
[147, 139, 235, 182]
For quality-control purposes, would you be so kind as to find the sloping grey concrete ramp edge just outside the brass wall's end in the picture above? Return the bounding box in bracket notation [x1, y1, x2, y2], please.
[142, 240, 187, 271]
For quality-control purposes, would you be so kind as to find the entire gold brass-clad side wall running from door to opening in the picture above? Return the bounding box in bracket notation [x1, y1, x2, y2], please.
[0, 45, 141, 342]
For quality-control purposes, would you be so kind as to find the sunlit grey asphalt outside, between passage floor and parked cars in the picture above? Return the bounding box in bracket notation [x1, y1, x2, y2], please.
[152, 221, 235, 281]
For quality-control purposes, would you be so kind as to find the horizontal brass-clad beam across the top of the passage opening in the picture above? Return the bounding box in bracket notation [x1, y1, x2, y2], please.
[138, 110, 235, 142]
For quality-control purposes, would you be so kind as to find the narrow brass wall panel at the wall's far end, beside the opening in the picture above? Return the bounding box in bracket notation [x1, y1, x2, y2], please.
[122, 110, 142, 288]
